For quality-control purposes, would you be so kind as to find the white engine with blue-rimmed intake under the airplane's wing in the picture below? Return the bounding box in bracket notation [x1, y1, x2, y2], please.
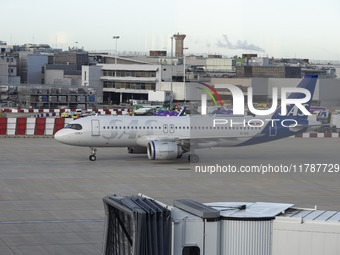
[147, 141, 184, 160]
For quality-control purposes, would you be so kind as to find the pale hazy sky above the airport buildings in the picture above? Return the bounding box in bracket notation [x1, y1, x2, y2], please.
[0, 0, 340, 60]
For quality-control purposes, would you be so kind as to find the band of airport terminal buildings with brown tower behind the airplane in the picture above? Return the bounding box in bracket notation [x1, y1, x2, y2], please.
[0, 37, 340, 107]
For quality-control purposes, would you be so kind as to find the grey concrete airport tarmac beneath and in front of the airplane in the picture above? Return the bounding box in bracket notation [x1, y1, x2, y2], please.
[0, 138, 340, 255]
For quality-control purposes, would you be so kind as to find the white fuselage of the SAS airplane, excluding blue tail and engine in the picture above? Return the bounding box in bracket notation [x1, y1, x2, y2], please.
[55, 116, 268, 147]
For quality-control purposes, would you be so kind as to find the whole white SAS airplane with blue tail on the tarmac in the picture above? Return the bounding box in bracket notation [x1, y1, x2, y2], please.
[54, 75, 321, 163]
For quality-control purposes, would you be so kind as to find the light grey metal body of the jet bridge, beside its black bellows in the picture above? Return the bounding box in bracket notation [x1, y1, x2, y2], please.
[106, 194, 340, 255]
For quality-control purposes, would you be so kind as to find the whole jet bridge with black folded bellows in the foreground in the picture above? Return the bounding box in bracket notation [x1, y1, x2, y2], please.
[103, 194, 340, 255]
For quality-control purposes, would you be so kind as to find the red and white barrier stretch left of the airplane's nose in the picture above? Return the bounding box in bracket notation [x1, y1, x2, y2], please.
[0, 118, 73, 136]
